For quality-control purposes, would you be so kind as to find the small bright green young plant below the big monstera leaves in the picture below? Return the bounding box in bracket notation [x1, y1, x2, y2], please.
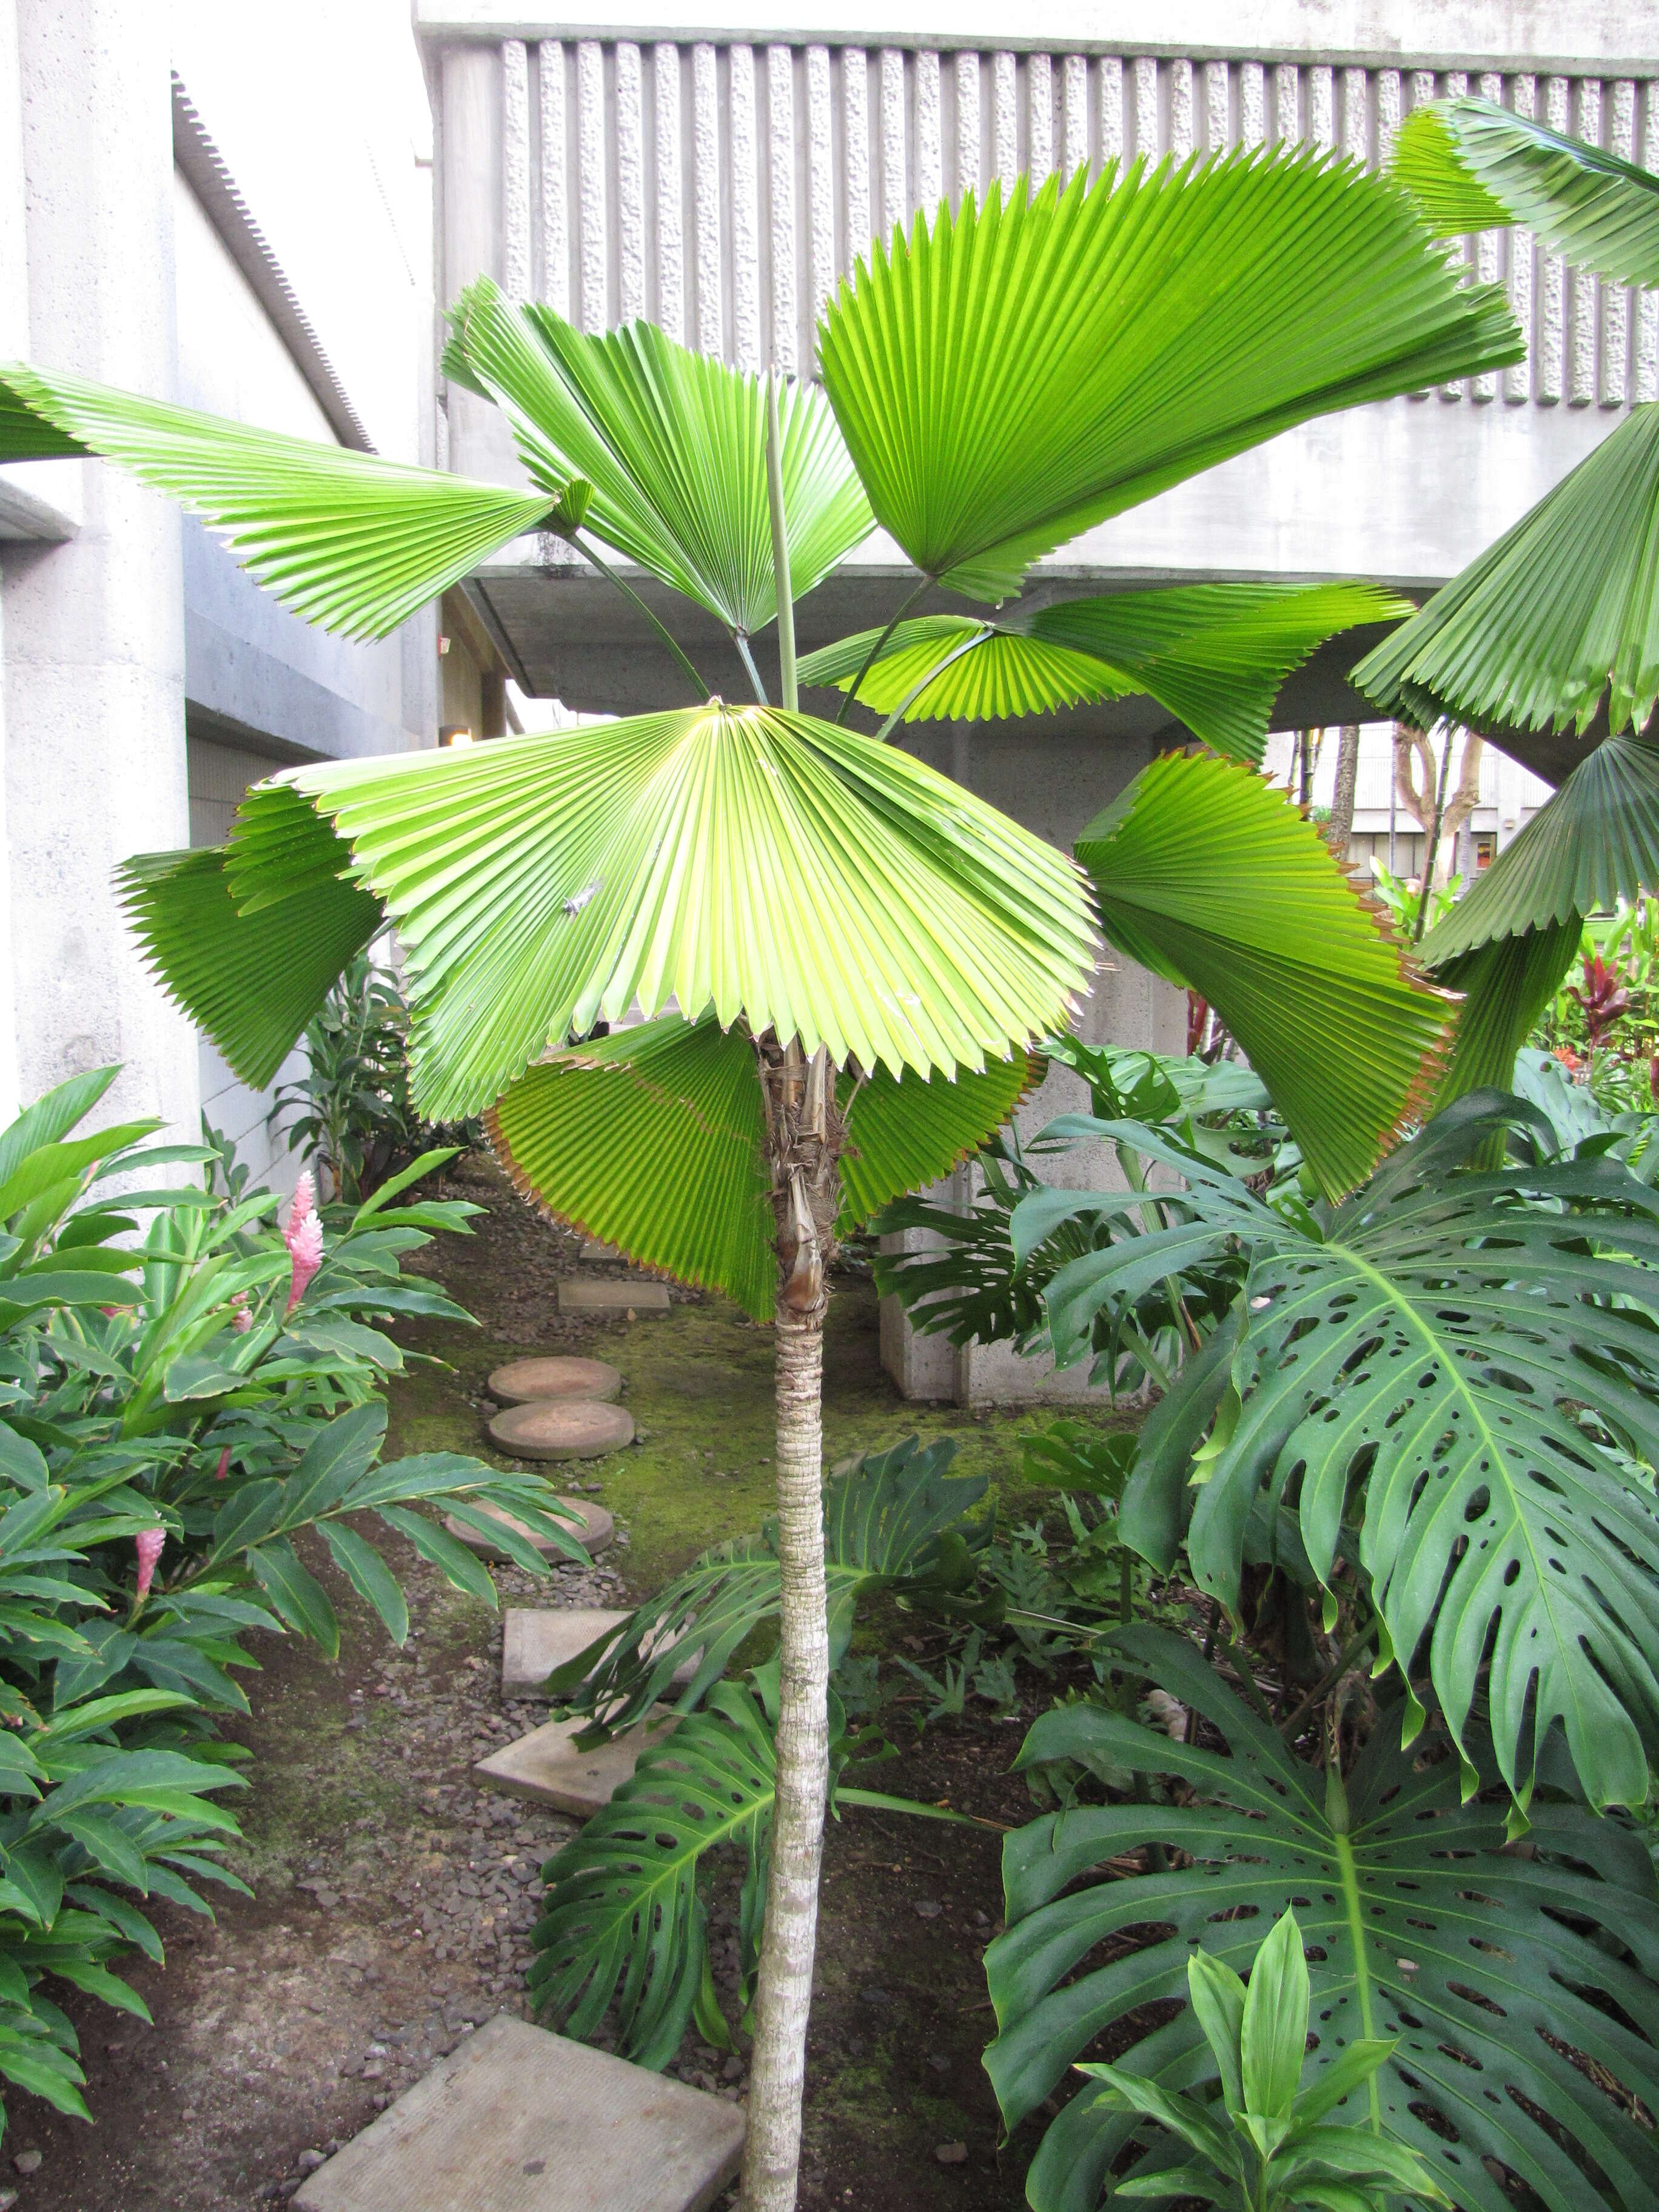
[1078, 1911, 1451, 2212]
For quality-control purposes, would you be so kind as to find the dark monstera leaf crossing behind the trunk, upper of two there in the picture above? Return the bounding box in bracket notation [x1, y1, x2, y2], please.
[546, 1436, 991, 1743]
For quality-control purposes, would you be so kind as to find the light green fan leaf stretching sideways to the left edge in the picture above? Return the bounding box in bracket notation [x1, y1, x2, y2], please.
[0, 363, 553, 637]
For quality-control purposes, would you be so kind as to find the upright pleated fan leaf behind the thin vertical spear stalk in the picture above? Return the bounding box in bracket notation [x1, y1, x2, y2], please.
[444, 279, 871, 635]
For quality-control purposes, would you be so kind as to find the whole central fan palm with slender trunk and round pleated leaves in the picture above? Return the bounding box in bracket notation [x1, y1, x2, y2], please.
[0, 150, 1518, 2212]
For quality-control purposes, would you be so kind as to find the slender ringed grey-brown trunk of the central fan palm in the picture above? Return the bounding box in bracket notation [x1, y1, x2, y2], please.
[739, 1037, 840, 2212]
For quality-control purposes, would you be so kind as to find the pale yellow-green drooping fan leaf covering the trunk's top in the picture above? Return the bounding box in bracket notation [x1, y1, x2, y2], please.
[198, 703, 1093, 1117]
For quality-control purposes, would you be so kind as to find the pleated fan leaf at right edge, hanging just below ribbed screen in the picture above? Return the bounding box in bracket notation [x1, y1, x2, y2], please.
[1354, 407, 1659, 737]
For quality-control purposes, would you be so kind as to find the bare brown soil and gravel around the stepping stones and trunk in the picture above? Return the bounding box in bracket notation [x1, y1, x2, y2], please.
[22, 1159, 1093, 2212]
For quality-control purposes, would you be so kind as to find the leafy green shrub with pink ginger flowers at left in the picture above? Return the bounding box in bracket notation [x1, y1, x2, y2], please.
[0, 1068, 581, 2123]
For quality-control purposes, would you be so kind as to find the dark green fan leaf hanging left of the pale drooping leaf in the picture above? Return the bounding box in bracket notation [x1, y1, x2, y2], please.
[117, 840, 383, 1090]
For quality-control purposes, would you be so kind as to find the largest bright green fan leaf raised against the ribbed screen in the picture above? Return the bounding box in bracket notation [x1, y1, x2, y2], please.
[819, 150, 1520, 600]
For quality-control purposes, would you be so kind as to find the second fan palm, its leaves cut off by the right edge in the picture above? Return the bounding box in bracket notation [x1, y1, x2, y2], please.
[1354, 99, 1659, 1104]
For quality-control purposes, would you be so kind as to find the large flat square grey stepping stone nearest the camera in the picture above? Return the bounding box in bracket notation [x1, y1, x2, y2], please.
[292, 2013, 743, 2212]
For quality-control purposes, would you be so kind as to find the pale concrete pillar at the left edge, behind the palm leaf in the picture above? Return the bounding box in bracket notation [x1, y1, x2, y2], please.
[0, 0, 199, 1137]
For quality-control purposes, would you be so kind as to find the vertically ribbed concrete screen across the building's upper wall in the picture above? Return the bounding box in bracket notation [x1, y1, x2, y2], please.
[458, 38, 1659, 409]
